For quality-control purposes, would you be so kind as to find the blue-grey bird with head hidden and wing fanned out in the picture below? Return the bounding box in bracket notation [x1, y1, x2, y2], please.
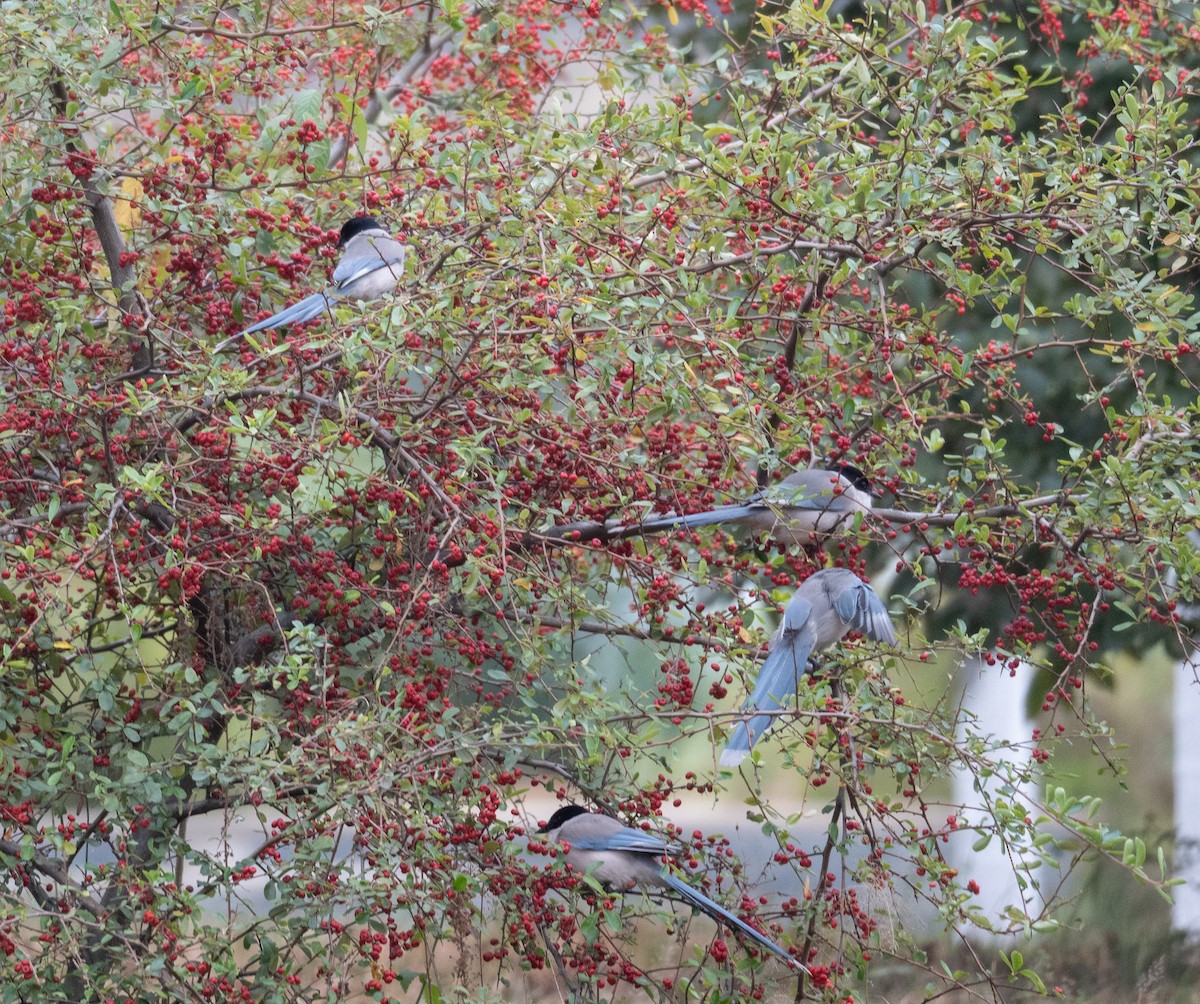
[721, 569, 896, 766]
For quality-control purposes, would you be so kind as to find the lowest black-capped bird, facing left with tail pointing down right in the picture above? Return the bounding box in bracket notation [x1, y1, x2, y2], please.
[538, 805, 808, 973]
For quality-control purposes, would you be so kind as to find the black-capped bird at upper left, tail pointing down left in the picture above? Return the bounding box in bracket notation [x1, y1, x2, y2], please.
[214, 216, 407, 351]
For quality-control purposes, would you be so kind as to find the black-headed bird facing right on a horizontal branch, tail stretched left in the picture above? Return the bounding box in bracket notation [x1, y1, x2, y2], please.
[541, 464, 874, 547]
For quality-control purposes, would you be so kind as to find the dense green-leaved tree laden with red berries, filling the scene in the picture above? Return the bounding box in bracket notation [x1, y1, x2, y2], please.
[0, 0, 1200, 1000]
